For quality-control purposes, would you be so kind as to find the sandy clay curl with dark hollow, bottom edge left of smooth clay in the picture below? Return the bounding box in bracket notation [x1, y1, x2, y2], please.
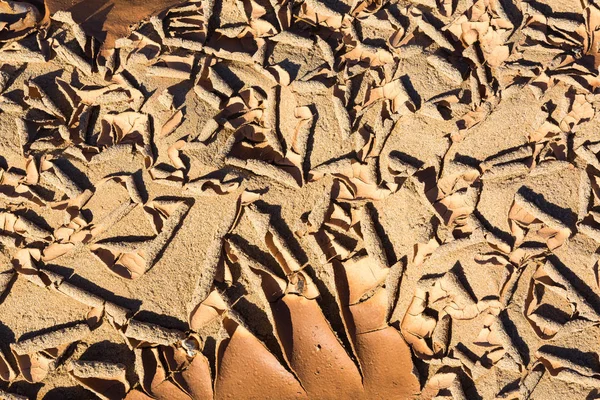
[69, 360, 129, 400]
